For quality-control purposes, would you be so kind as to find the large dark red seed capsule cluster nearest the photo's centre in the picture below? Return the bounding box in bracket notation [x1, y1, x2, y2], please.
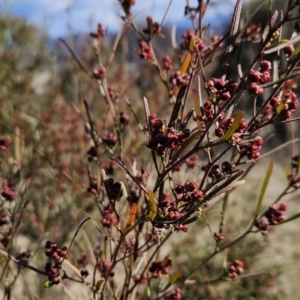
[145, 114, 190, 156]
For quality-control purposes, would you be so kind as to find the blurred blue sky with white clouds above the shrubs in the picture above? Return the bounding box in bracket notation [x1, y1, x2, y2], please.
[0, 0, 235, 38]
